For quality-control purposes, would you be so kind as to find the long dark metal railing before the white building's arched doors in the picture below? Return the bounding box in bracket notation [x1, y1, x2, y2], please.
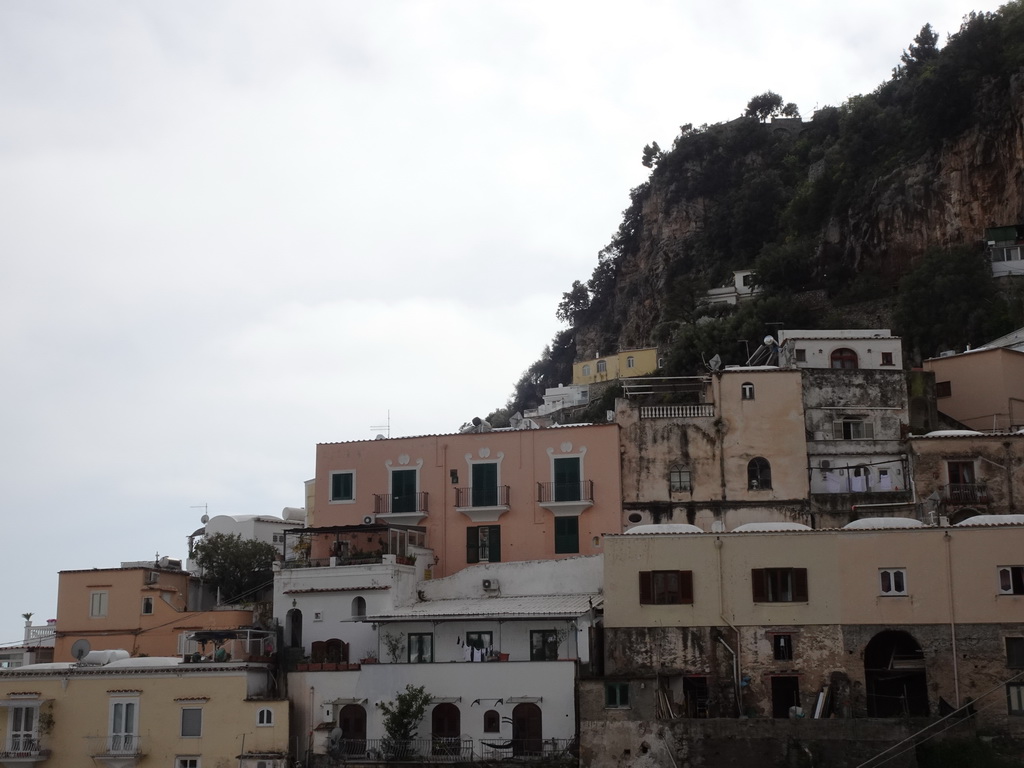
[331, 736, 578, 764]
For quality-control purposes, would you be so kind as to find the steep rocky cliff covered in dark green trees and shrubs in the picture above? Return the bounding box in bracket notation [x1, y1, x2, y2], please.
[489, 0, 1024, 424]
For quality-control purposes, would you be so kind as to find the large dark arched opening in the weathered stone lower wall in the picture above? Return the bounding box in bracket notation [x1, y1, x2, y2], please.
[864, 630, 928, 718]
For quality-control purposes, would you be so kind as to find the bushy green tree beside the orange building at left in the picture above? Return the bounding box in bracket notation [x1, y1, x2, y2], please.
[191, 534, 278, 603]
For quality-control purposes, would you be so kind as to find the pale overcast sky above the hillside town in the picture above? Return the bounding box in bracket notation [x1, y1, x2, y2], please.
[0, 0, 996, 643]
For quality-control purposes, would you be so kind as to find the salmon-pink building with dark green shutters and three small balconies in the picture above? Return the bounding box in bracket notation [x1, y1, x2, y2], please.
[309, 424, 622, 577]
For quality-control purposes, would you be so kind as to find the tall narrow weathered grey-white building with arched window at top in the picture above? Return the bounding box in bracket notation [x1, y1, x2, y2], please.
[778, 329, 913, 527]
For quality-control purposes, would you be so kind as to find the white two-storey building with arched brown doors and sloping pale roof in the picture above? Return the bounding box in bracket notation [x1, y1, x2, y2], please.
[289, 556, 602, 766]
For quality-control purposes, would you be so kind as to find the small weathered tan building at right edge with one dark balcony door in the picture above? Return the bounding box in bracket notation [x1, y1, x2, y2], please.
[907, 430, 1024, 523]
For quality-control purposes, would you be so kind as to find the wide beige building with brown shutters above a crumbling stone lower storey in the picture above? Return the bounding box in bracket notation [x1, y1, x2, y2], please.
[581, 516, 1024, 768]
